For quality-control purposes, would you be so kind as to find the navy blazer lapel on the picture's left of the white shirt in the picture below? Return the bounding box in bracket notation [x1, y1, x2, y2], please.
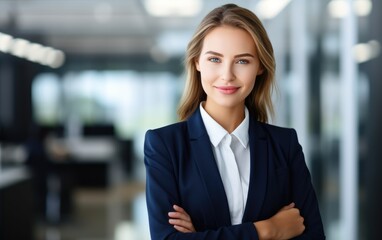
[187, 109, 231, 226]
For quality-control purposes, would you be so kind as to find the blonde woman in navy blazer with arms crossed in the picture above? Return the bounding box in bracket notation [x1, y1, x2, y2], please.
[144, 4, 325, 240]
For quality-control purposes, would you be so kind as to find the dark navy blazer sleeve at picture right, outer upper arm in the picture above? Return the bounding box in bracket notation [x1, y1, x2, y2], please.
[288, 130, 325, 240]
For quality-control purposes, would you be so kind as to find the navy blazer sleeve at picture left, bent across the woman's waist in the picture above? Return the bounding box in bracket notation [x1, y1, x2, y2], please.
[144, 130, 258, 240]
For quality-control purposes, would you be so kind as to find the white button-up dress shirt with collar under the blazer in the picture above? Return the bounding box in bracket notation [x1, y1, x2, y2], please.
[199, 103, 250, 225]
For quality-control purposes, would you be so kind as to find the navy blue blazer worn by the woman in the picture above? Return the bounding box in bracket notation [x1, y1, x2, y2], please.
[144, 109, 325, 240]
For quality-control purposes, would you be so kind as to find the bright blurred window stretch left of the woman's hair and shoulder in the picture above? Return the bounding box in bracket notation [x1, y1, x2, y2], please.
[33, 70, 181, 138]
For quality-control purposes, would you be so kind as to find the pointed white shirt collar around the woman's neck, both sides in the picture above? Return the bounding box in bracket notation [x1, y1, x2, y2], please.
[199, 102, 249, 148]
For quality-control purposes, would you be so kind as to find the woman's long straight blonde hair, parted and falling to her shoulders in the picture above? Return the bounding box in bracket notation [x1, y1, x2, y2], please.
[178, 4, 276, 122]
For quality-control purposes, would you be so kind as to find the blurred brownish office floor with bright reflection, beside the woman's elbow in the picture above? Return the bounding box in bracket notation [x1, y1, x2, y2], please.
[35, 165, 149, 240]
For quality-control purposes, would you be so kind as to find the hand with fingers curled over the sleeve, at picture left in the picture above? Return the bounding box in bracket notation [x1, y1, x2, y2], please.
[168, 205, 195, 233]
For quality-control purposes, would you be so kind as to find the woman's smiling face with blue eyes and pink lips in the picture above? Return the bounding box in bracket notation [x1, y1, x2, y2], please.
[195, 26, 262, 109]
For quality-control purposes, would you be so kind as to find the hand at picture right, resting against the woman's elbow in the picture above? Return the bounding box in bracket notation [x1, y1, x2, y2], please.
[254, 203, 305, 240]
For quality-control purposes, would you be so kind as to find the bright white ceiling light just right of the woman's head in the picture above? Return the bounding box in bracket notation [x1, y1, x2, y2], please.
[255, 0, 291, 19]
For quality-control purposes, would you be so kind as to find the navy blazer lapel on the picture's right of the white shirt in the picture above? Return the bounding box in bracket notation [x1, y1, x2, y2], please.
[243, 119, 268, 222]
